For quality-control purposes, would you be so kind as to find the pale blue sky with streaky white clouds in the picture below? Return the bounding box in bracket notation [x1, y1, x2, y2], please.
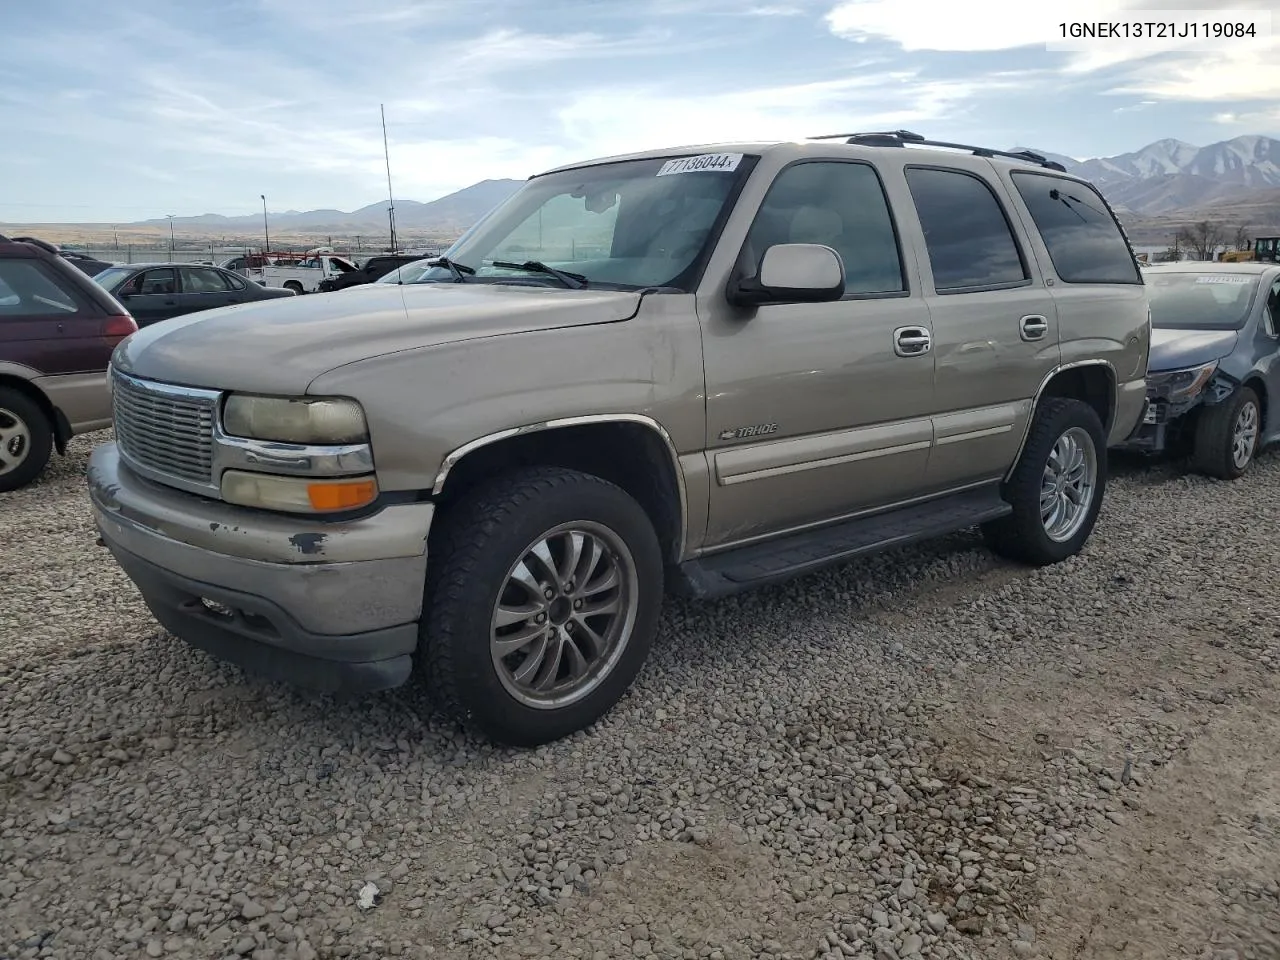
[0, 0, 1280, 223]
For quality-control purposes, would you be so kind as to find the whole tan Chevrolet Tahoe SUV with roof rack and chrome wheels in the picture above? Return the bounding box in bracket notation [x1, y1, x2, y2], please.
[88, 132, 1149, 745]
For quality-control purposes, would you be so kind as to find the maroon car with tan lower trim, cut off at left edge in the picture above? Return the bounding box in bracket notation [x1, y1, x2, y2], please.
[0, 236, 138, 493]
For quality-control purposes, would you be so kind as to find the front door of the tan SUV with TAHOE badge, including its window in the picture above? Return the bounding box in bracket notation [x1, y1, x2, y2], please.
[699, 160, 934, 547]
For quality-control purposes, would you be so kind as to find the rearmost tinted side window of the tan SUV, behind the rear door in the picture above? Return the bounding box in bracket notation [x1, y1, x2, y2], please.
[1012, 173, 1142, 283]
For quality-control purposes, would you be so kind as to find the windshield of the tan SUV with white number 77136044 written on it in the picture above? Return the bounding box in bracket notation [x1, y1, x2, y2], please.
[419, 154, 755, 292]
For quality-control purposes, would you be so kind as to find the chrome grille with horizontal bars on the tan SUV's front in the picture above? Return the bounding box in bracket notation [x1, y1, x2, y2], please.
[111, 372, 218, 486]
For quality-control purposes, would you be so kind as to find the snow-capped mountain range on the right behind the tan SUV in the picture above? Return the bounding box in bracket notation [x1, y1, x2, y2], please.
[1015, 136, 1280, 216]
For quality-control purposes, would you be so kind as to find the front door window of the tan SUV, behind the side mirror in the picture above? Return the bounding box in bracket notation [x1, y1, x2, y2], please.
[744, 161, 906, 296]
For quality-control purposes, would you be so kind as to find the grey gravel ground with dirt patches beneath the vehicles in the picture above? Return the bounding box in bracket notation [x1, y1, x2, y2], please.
[0, 435, 1280, 960]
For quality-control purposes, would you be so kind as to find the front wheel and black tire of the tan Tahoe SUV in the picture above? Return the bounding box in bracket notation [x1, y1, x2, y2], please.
[420, 467, 663, 746]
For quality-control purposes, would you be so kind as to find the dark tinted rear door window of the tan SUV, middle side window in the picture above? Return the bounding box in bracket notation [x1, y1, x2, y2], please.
[906, 168, 1028, 291]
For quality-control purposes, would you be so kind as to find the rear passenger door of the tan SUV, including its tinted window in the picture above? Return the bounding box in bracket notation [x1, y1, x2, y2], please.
[902, 156, 1060, 490]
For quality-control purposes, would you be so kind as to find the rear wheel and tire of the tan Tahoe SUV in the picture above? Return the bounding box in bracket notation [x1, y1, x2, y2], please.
[982, 397, 1107, 567]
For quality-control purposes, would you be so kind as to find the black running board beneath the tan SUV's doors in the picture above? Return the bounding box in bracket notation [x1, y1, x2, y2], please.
[672, 484, 1012, 599]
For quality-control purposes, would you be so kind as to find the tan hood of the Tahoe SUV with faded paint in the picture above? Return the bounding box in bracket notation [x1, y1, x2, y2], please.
[113, 283, 640, 396]
